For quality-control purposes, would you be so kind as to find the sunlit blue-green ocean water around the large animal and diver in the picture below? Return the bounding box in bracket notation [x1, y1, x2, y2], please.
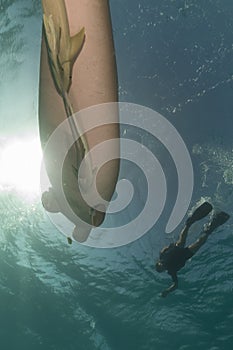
[0, 0, 233, 350]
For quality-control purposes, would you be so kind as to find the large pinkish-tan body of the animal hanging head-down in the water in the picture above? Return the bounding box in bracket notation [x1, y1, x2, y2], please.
[39, 0, 119, 241]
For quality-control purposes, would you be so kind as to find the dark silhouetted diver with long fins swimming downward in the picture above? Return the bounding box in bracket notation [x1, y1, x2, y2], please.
[155, 202, 230, 297]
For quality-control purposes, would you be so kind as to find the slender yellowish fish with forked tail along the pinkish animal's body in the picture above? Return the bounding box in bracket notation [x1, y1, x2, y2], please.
[42, 0, 93, 190]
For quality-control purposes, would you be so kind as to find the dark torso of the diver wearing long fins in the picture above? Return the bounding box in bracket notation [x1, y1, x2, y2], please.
[159, 243, 193, 282]
